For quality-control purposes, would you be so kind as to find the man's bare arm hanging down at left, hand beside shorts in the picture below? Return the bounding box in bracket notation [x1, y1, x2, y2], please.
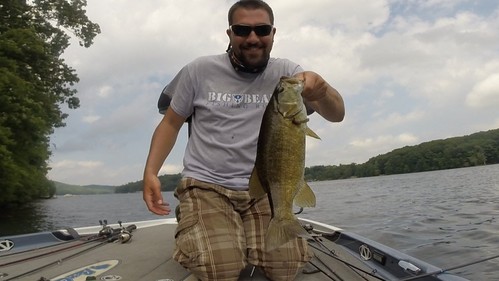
[143, 108, 185, 215]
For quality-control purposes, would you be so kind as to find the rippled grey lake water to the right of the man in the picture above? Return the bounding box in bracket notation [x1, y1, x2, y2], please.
[304, 165, 499, 280]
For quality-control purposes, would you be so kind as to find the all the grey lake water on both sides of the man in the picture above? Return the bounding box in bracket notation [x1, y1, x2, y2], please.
[0, 165, 499, 280]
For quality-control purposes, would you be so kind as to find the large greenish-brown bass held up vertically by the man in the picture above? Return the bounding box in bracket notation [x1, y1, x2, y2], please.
[249, 77, 320, 251]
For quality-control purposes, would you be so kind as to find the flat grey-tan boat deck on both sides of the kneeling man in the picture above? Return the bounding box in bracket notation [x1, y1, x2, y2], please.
[0, 220, 465, 281]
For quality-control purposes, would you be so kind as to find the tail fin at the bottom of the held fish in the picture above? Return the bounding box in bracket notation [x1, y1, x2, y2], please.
[265, 215, 308, 252]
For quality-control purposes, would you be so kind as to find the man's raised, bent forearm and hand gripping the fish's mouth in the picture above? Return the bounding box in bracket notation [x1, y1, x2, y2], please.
[295, 71, 345, 122]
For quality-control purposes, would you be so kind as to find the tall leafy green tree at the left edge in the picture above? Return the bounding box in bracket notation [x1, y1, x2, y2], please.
[0, 0, 100, 205]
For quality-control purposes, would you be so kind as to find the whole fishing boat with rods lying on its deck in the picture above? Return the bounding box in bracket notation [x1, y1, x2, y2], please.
[0, 218, 467, 281]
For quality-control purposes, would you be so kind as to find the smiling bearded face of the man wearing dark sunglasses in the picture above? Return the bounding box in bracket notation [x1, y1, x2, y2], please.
[227, 8, 275, 68]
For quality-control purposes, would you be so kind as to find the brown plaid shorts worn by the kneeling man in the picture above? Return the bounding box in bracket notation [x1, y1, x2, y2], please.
[173, 178, 312, 280]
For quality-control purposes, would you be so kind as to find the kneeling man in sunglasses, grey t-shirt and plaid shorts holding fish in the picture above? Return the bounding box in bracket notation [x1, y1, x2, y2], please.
[143, 0, 344, 280]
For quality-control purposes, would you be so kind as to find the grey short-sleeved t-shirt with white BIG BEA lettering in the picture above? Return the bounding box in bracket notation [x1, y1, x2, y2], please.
[163, 54, 303, 190]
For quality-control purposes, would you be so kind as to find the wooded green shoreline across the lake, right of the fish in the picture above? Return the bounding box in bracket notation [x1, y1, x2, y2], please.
[305, 129, 499, 181]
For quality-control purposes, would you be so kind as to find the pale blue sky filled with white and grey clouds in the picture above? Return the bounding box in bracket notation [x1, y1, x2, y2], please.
[48, 0, 499, 185]
